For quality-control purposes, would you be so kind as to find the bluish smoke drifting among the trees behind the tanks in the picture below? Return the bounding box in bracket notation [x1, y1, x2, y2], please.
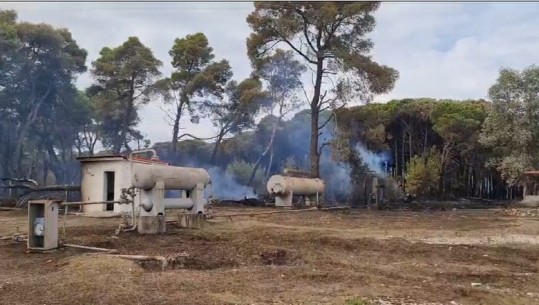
[160, 112, 391, 202]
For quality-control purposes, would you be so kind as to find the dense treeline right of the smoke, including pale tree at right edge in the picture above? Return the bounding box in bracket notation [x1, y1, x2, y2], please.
[337, 65, 539, 199]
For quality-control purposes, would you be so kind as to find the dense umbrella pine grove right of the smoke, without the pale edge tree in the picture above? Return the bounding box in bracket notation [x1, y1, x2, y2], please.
[337, 98, 509, 198]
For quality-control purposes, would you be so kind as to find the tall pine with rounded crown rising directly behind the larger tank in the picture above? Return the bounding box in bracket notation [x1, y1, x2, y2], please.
[156, 33, 232, 153]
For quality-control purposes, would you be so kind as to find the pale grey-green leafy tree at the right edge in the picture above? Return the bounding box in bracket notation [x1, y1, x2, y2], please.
[480, 65, 539, 185]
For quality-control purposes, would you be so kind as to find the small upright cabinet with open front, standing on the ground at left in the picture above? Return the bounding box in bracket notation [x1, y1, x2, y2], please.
[28, 200, 61, 251]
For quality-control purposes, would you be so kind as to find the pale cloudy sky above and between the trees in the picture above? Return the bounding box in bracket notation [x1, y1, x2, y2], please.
[1, 2, 539, 143]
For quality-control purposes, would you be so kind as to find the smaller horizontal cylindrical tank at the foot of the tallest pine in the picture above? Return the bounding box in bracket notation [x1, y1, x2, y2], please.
[266, 175, 325, 196]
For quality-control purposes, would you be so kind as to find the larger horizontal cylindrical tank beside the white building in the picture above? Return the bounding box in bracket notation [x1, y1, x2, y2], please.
[131, 162, 210, 190]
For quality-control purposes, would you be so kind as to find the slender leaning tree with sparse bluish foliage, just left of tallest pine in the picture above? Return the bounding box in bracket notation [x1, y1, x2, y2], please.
[248, 49, 306, 186]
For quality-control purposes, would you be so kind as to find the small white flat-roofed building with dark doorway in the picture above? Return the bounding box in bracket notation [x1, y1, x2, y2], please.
[77, 155, 166, 214]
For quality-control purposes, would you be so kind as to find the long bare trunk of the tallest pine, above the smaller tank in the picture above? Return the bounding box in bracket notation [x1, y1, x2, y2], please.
[309, 58, 324, 178]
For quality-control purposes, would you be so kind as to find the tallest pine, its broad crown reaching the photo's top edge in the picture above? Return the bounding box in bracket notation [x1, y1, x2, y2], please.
[247, 1, 398, 177]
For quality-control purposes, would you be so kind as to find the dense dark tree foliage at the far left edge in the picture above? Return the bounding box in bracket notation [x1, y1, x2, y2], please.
[0, 10, 87, 180]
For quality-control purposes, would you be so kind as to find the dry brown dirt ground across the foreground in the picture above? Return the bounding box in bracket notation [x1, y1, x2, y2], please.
[0, 208, 539, 305]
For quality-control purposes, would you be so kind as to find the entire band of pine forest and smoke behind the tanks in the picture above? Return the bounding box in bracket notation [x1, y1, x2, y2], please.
[0, 2, 539, 201]
